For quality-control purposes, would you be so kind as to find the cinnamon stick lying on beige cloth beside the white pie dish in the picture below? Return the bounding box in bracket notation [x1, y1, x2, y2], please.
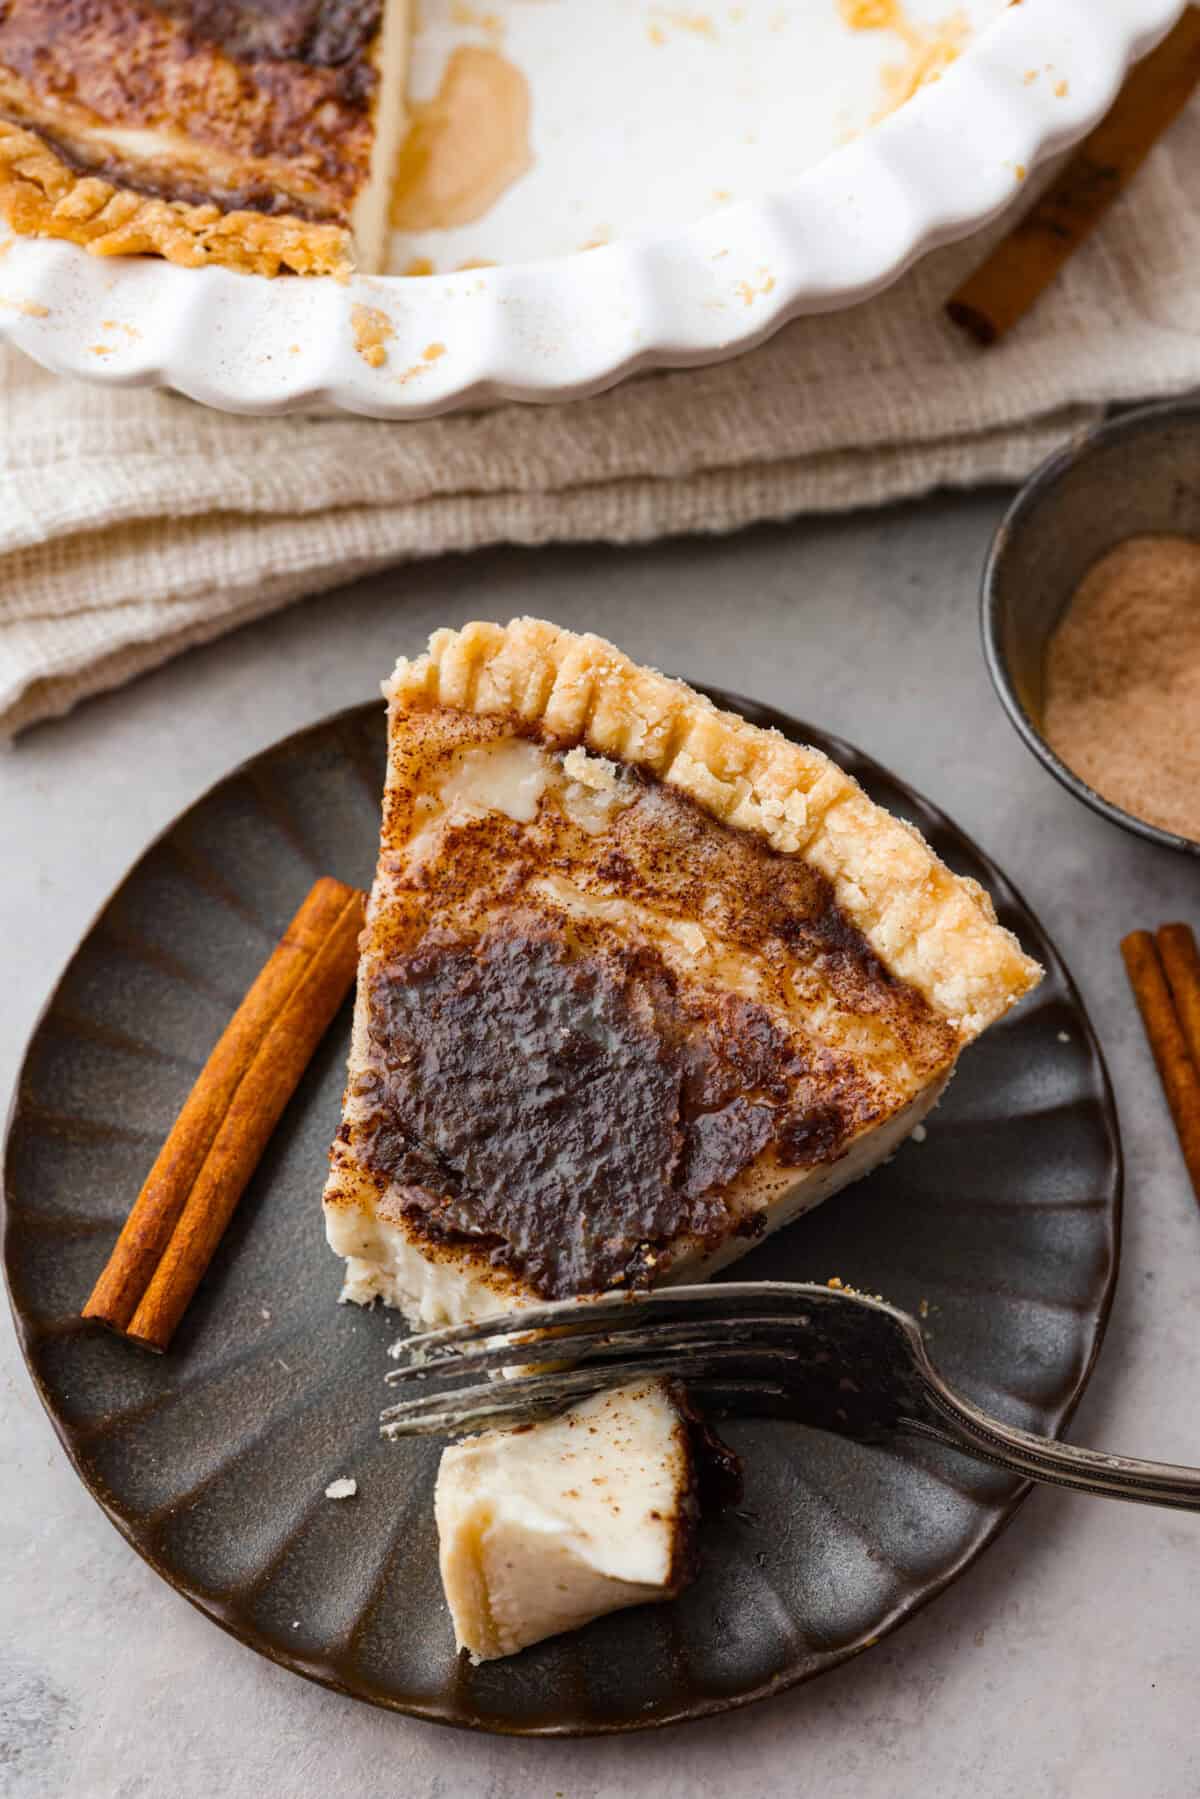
[946, 5, 1200, 345]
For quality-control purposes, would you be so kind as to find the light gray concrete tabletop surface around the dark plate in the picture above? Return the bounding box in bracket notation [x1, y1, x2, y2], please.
[0, 493, 1200, 1799]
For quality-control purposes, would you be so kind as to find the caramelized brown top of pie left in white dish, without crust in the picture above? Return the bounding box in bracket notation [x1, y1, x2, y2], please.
[0, 0, 381, 221]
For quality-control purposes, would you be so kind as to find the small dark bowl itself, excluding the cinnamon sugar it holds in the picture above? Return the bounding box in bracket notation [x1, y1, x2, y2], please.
[982, 399, 1200, 856]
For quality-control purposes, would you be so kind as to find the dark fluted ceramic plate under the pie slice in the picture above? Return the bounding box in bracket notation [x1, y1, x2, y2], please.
[5, 696, 1121, 1732]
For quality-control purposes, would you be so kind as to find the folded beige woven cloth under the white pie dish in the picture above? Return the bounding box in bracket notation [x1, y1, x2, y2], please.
[0, 94, 1200, 734]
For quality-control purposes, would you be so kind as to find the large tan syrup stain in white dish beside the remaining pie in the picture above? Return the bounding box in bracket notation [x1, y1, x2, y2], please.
[392, 45, 533, 232]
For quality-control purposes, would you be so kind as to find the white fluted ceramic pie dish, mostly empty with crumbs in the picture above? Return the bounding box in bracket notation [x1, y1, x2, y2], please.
[0, 0, 1182, 419]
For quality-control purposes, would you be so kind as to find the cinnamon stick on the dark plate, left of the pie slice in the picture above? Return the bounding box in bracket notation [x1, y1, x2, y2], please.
[83, 878, 363, 1349]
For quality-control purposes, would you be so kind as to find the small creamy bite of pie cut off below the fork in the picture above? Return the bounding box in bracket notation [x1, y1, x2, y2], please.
[434, 1382, 719, 1662]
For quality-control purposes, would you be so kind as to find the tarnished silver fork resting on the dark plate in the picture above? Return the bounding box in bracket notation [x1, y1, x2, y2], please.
[381, 1281, 1200, 1511]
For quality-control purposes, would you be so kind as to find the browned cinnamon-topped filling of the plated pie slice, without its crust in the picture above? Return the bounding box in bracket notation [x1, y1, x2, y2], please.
[327, 720, 959, 1299]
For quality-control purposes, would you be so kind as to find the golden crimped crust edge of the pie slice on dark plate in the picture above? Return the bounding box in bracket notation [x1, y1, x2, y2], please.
[383, 619, 1042, 1042]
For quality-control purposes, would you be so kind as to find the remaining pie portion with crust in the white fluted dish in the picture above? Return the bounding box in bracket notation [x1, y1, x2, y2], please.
[0, 0, 408, 275]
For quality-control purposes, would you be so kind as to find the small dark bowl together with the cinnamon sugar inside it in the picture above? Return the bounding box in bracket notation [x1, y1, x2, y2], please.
[982, 399, 1200, 855]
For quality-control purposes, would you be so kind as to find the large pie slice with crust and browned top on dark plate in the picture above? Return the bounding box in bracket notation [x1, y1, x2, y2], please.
[324, 619, 1038, 1326]
